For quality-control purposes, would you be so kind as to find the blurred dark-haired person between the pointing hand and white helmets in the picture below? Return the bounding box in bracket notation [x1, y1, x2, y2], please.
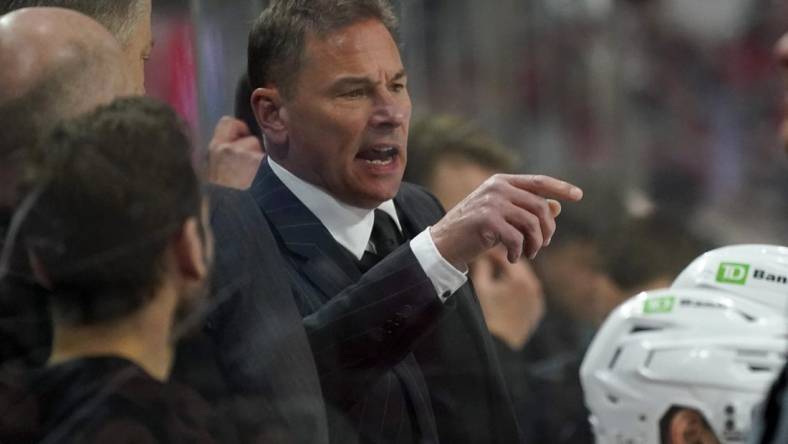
[524, 177, 707, 443]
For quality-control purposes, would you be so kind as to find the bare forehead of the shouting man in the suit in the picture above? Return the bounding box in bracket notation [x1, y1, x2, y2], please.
[304, 19, 402, 74]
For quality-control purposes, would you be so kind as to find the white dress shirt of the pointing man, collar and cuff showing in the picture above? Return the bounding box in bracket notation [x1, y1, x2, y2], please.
[266, 156, 467, 302]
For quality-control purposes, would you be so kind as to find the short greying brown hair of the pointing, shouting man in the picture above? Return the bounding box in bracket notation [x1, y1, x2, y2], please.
[248, 0, 398, 96]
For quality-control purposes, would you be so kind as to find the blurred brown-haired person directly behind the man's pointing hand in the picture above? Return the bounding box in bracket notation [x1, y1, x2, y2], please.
[404, 115, 544, 442]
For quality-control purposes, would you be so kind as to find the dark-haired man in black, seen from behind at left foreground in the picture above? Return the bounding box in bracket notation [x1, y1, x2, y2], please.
[0, 98, 223, 443]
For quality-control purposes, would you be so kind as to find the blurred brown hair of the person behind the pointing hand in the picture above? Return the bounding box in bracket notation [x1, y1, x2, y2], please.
[405, 115, 516, 188]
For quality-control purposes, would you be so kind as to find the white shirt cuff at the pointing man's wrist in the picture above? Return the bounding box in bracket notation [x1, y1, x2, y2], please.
[410, 227, 468, 302]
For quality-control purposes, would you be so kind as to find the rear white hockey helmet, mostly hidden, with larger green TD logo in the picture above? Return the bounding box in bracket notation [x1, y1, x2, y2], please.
[671, 245, 788, 313]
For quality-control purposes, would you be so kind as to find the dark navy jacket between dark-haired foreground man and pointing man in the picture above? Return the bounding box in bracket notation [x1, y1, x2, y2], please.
[173, 186, 328, 443]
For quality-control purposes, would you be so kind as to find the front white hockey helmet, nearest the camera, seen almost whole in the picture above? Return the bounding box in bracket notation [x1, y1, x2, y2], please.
[580, 286, 788, 444]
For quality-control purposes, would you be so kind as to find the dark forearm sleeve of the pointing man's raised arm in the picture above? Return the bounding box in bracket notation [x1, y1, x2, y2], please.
[304, 245, 451, 405]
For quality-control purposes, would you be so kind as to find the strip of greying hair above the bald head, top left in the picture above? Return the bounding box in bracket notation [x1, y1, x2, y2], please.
[0, 0, 145, 46]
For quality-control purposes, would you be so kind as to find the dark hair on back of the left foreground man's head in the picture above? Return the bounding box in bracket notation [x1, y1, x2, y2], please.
[23, 97, 201, 324]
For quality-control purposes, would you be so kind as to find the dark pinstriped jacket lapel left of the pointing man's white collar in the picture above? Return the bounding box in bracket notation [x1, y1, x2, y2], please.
[250, 162, 361, 302]
